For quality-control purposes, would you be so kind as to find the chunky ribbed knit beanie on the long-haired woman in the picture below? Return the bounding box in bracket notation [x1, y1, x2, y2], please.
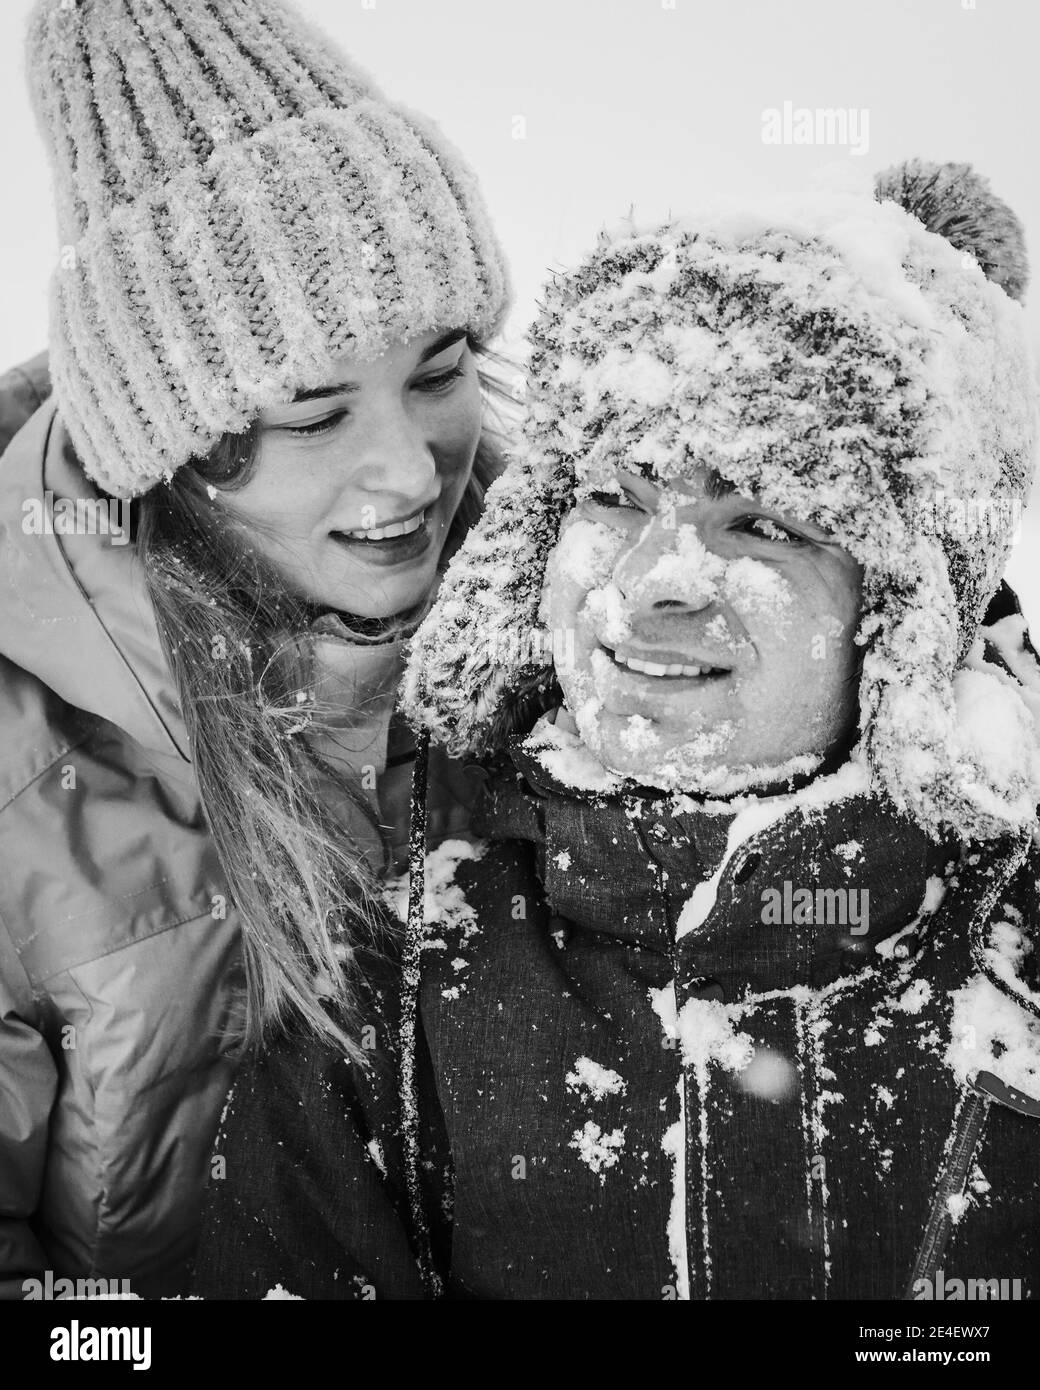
[28, 0, 509, 496]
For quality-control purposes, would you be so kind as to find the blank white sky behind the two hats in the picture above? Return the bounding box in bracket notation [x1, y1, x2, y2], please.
[0, 0, 1040, 614]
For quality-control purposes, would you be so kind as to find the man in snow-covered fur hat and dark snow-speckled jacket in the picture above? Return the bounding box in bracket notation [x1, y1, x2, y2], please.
[197, 164, 1040, 1300]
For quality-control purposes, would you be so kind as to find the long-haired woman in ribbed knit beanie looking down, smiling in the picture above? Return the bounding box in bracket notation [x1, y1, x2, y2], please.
[0, 0, 507, 1297]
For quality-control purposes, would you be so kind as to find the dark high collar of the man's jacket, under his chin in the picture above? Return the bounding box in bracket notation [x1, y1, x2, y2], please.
[476, 738, 959, 998]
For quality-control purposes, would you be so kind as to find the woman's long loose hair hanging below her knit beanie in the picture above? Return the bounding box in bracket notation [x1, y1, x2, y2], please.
[135, 342, 510, 1058]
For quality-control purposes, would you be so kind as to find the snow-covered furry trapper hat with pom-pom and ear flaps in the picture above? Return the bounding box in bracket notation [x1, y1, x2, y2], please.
[403, 161, 1040, 838]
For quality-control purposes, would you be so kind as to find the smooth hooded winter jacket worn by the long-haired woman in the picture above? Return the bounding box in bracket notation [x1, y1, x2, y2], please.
[0, 375, 478, 1298]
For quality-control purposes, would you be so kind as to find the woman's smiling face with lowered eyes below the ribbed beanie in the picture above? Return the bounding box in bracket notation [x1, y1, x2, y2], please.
[224, 329, 481, 617]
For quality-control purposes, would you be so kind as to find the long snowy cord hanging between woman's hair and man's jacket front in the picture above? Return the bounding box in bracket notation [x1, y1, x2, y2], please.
[399, 730, 444, 1298]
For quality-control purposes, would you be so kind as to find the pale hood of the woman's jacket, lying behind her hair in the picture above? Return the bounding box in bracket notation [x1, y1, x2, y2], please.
[0, 400, 189, 766]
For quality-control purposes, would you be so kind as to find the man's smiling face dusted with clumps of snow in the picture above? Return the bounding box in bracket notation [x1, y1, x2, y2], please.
[544, 470, 862, 792]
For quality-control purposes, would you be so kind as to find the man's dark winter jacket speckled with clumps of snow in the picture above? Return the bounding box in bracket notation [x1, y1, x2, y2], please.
[190, 614, 1040, 1300]
